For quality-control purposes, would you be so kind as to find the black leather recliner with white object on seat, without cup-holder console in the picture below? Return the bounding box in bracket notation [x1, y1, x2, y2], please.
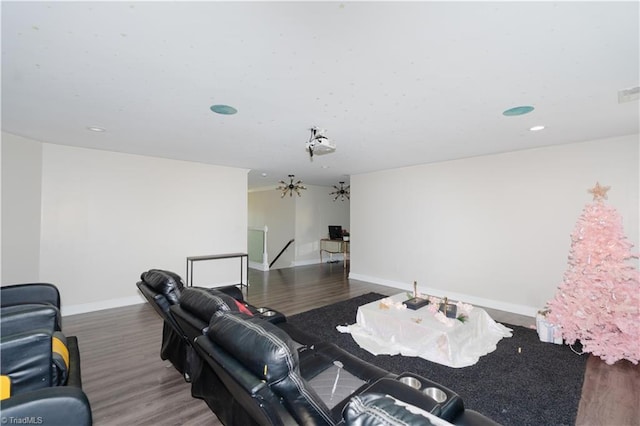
[196, 311, 389, 425]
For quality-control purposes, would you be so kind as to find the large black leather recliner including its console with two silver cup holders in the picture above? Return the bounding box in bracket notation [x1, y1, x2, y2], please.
[195, 311, 495, 425]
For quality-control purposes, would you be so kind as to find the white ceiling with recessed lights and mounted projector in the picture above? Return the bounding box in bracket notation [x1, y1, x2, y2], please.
[1, 1, 640, 187]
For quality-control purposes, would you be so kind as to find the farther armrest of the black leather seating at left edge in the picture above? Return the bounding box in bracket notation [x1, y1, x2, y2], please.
[0, 303, 60, 336]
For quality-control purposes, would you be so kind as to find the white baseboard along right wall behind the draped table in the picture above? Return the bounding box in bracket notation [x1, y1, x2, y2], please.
[349, 273, 539, 317]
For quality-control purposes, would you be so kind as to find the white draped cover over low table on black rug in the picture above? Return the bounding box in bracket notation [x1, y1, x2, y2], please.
[337, 293, 511, 368]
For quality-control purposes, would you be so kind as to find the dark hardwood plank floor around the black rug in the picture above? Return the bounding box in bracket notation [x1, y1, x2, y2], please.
[63, 263, 640, 426]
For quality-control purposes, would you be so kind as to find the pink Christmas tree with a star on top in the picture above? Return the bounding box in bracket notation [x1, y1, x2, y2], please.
[547, 183, 640, 364]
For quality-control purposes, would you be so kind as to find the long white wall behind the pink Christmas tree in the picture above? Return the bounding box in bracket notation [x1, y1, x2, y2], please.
[350, 135, 640, 315]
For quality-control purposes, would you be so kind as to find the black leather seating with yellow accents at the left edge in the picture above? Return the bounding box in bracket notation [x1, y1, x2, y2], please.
[0, 283, 92, 426]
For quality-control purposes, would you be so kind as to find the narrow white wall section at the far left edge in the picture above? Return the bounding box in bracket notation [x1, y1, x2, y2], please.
[2, 133, 42, 285]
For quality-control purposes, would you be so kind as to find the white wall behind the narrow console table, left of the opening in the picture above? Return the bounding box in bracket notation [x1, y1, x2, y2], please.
[2, 135, 247, 315]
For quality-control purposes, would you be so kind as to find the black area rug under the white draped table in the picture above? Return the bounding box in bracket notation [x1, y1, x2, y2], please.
[287, 293, 587, 426]
